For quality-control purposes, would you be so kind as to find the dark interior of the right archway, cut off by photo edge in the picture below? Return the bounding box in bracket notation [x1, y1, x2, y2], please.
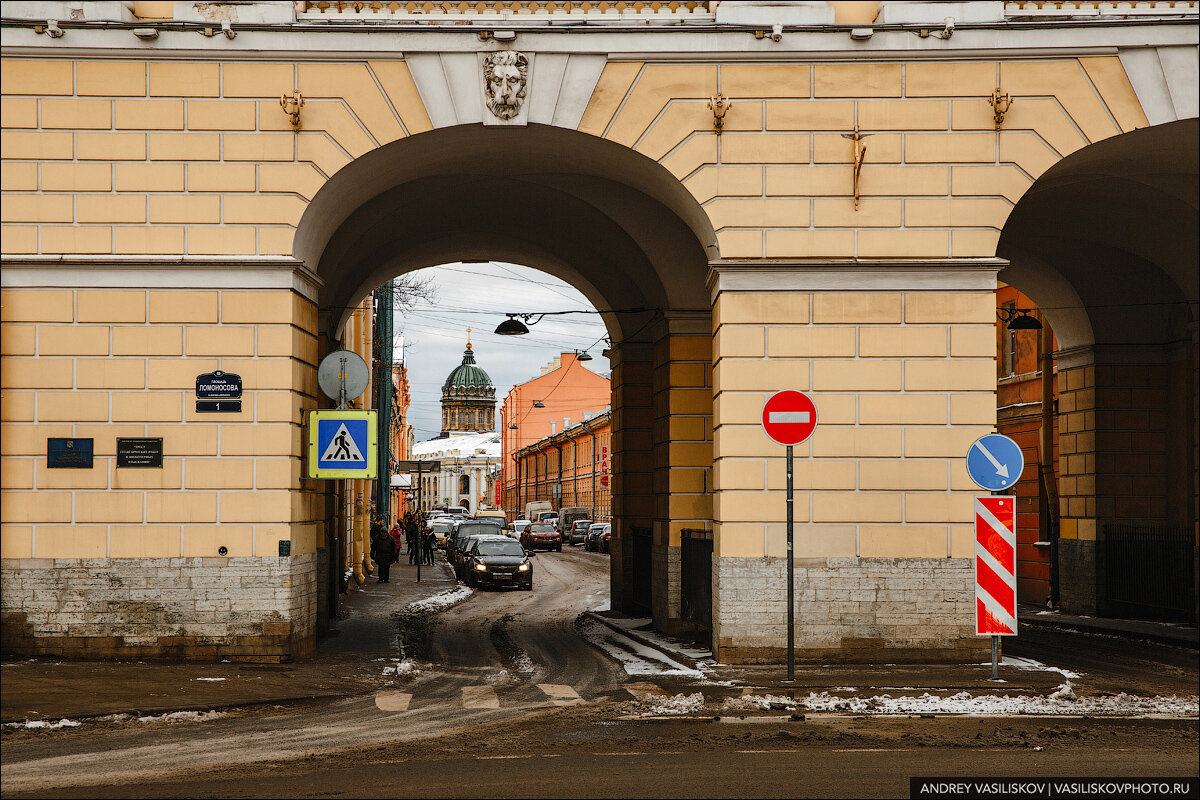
[997, 119, 1200, 614]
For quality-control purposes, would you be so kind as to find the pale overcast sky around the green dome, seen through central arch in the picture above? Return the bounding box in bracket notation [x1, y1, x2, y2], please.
[395, 261, 610, 441]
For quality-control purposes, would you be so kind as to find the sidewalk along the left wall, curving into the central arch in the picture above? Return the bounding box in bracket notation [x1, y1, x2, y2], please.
[0, 557, 457, 722]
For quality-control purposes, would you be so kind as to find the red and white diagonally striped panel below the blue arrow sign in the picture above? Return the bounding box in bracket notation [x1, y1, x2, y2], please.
[976, 495, 1016, 636]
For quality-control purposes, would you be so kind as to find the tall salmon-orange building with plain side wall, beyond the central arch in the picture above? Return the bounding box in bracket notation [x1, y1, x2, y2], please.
[497, 353, 612, 519]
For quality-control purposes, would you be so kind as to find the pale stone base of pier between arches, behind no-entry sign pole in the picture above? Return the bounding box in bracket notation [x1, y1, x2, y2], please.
[713, 558, 991, 663]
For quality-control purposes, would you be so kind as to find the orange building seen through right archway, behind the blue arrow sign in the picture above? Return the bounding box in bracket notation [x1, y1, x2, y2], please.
[996, 285, 1058, 606]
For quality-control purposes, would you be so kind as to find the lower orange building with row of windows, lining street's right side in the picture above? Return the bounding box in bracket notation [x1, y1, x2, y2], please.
[505, 411, 612, 522]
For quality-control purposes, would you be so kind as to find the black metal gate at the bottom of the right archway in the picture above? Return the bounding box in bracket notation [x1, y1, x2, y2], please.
[1102, 525, 1196, 622]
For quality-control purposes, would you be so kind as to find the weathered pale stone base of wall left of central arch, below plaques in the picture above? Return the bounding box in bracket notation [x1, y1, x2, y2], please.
[0, 554, 317, 662]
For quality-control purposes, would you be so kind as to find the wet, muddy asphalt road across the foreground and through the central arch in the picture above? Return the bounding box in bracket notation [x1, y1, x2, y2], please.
[4, 548, 1198, 798]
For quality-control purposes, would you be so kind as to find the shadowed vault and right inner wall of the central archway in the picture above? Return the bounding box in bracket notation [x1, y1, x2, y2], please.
[294, 125, 718, 630]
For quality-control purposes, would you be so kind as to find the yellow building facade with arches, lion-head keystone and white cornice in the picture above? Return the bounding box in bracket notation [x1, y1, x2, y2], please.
[0, 2, 1196, 661]
